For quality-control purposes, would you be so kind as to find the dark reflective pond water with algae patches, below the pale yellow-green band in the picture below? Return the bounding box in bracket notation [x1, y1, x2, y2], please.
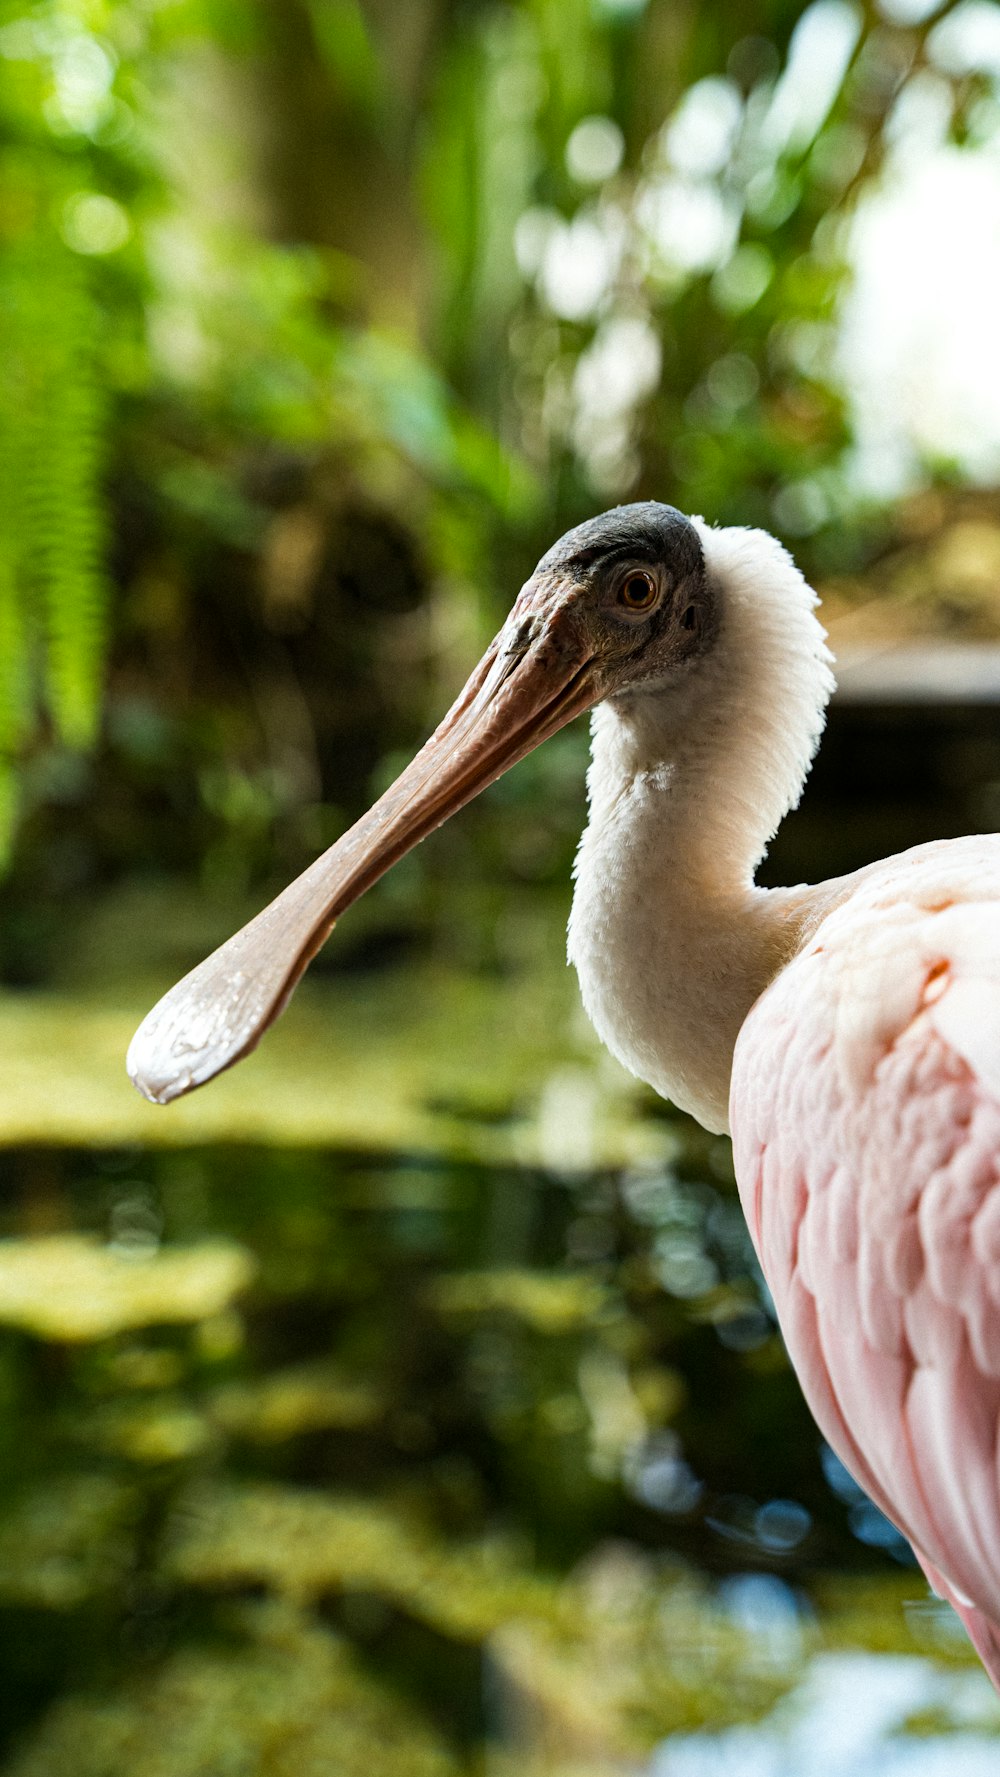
[0, 1107, 1000, 1777]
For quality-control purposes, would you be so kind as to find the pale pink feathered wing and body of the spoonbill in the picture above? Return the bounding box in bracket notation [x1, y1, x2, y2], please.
[730, 867, 1000, 1690]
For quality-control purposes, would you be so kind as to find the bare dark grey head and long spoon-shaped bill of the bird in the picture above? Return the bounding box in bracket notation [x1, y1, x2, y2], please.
[128, 501, 718, 1104]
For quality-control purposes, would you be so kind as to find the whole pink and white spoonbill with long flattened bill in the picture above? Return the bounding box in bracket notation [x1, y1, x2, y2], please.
[128, 501, 1000, 1690]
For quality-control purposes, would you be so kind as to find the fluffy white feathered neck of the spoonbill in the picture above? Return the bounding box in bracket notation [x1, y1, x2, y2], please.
[570, 521, 833, 1130]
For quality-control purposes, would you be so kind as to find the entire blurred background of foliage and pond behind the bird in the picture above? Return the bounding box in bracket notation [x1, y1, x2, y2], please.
[0, 0, 1000, 1777]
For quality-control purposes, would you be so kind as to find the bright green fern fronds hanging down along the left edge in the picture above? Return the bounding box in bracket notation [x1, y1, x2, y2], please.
[0, 0, 130, 860]
